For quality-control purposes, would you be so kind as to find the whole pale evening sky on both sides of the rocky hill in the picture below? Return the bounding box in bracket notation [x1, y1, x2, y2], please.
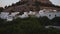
[0, 0, 60, 7]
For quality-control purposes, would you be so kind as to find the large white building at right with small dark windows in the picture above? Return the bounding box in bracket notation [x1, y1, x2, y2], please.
[39, 10, 60, 19]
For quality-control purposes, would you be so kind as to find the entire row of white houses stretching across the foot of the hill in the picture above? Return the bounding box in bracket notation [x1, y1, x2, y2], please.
[0, 9, 60, 21]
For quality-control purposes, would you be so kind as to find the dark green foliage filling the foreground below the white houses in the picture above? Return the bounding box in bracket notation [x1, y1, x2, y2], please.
[0, 17, 60, 34]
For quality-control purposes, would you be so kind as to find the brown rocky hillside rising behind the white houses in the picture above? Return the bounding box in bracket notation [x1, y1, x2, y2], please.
[4, 0, 60, 12]
